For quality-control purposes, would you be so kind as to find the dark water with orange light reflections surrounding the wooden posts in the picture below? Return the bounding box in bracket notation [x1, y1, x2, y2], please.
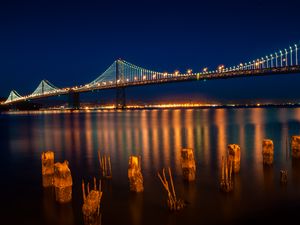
[0, 108, 300, 225]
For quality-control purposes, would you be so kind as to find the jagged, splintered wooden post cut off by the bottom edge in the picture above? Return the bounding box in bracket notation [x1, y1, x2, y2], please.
[82, 177, 102, 225]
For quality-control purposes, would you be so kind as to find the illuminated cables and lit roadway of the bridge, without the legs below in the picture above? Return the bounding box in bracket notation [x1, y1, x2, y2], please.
[2, 41, 300, 104]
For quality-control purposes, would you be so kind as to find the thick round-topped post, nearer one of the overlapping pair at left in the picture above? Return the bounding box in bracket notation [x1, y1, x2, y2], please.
[54, 160, 73, 203]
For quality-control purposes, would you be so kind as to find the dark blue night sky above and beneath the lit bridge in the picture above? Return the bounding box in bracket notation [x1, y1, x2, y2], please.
[0, 0, 300, 103]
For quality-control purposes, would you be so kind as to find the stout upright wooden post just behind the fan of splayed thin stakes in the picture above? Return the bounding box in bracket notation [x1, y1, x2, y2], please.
[181, 148, 196, 181]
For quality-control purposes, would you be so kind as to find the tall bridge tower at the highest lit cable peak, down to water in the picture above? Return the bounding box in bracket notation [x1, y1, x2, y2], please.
[116, 59, 126, 109]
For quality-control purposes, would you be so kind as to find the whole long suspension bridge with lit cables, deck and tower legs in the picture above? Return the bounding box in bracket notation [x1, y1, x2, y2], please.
[2, 44, 300, 108]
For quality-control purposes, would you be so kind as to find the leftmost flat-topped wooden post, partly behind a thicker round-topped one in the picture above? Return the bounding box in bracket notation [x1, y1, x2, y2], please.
[41, 151, 54, 187]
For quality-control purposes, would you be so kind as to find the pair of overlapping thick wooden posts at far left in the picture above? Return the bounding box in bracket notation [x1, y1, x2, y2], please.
[41, 151, 73, 203]
